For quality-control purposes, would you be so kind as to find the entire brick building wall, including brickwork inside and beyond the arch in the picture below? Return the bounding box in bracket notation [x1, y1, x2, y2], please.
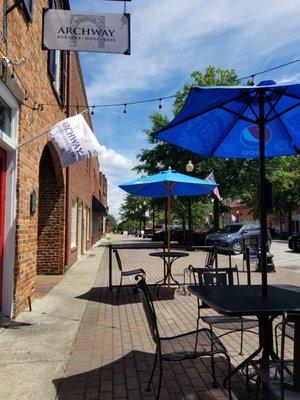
[0, 0, 106, 313]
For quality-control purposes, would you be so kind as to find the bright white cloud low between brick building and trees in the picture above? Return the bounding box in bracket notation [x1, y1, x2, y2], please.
[99, 145, 137, 219]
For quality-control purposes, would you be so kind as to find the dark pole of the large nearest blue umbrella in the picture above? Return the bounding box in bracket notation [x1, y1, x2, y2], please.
[258, 89, 268, 296]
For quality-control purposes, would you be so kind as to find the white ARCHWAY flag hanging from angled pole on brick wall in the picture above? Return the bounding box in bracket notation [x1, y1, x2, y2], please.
[51, 114, 101, 167]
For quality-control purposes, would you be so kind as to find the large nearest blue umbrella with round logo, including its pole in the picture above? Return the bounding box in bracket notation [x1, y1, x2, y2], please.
[157, 81, 300, 296]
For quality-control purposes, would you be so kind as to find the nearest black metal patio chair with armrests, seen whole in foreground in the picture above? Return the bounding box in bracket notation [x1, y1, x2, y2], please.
[135, 275, 232, 399]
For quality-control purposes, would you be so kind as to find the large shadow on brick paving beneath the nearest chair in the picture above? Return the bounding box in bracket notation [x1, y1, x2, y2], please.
[53, 350, 247, 400]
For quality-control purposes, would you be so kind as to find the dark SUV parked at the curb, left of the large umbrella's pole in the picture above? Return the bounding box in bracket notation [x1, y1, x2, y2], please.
[205, 224, 271, 254]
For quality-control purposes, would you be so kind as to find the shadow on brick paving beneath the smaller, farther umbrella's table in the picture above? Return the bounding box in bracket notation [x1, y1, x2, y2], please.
[76, 285, 175, 306]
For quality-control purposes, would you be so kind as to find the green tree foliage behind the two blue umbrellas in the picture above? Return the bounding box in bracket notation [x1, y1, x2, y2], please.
[122, 66, 300, 226]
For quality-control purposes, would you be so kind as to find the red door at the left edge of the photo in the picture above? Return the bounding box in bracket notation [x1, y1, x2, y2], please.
[0, 148, 6, 311]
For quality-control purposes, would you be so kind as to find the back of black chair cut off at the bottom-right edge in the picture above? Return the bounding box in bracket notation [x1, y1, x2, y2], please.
[280, 312, 300, 398]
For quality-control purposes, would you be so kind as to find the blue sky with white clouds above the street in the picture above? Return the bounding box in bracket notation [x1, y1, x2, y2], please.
[70, 0, 300, 218]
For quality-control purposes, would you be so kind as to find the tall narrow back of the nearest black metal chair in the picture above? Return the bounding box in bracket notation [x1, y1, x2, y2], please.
[135, 275, 159, 344]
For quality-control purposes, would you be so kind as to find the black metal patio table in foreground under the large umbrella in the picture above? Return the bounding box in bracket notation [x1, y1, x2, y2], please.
[188, 285, 300, 383]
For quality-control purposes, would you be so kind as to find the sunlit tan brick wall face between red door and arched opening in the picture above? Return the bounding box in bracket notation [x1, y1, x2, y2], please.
[0, 0, 68, 313]
